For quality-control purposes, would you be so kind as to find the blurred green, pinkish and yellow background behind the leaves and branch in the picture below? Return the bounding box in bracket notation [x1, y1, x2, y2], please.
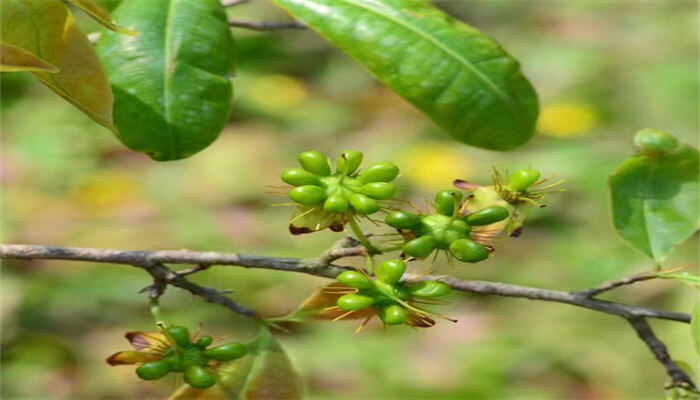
[0, 1, 698, 399]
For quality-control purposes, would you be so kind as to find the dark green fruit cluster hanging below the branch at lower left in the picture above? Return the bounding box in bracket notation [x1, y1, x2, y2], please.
[136, 326, 247, 389]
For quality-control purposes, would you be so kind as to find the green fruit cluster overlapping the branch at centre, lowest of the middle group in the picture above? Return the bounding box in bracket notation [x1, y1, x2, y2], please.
[336, 260, 451, 325]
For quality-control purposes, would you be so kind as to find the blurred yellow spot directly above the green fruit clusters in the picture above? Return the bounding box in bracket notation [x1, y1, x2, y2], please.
[396, 142, 472, 190]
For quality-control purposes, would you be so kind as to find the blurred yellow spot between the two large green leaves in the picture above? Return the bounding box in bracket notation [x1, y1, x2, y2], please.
[246, 75, 309, 113]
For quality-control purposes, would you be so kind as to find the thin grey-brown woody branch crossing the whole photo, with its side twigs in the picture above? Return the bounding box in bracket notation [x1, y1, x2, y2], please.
[0, 241, 695, 390]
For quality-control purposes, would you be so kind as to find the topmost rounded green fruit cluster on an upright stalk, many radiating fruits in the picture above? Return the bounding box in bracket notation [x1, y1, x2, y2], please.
[282, 150, 399, 215]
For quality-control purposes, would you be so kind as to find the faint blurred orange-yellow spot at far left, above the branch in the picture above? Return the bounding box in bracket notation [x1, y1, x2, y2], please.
[74, 170, 138, 212]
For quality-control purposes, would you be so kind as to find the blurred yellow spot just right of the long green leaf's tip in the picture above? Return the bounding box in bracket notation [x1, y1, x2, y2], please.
[537, 103, 598, 137]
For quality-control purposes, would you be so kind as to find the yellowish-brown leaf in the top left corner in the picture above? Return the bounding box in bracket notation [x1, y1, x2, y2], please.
[0, 0, 114, 129]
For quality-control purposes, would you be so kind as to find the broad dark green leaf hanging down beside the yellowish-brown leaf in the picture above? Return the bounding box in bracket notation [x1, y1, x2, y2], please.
[98, 0, 234, 161]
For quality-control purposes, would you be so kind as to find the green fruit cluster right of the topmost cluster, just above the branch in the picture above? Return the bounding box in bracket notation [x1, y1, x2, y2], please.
[386, 190, 509, 263]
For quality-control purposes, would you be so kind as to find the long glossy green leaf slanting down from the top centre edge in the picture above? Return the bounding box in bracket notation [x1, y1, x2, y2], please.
[273, 0, 538, 150]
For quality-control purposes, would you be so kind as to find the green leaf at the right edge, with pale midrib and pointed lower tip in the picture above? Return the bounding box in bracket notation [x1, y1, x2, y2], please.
[609, 130, 700, 264]
